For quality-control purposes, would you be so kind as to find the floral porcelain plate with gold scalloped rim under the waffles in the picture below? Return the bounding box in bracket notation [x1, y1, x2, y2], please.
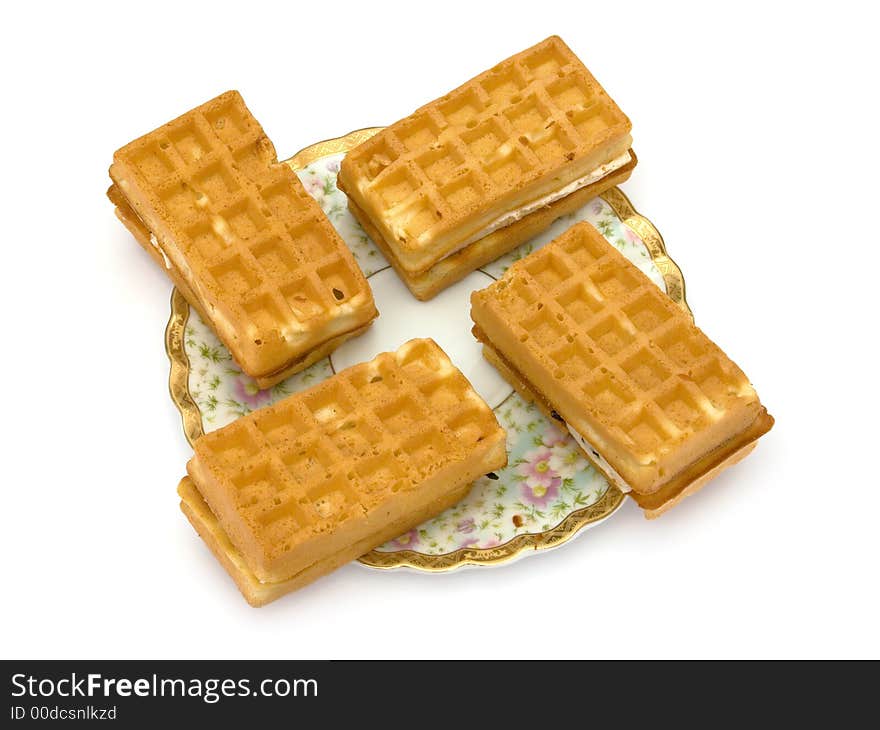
[166, 128, 687, 571]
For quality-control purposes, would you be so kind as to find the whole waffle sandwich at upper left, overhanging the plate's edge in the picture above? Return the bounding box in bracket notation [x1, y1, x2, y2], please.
[108, 91, 377, 388]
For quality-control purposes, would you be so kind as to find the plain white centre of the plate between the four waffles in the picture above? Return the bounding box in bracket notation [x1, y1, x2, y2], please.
[330, 267, 513, 408]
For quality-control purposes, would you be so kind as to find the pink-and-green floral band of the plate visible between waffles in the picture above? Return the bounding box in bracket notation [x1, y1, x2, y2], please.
[184, 148, 665, 556]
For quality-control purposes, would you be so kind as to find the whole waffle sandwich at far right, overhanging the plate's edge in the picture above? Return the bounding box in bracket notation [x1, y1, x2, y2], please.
[471, 222, 773, 518]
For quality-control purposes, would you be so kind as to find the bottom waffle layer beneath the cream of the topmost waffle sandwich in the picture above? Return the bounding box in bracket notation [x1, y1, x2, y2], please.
[348, 154, 636, 301]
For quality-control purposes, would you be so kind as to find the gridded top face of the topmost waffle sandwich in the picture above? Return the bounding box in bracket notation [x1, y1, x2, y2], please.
[343, 37, 630, 258]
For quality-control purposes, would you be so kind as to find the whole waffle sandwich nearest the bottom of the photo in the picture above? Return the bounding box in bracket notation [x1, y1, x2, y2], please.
[178, 340, 507, 605]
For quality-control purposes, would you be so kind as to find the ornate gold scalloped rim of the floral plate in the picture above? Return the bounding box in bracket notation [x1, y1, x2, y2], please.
[165, 127, 693, 572]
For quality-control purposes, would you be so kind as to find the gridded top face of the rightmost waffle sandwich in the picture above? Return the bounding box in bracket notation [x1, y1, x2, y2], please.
[485, 223, 755, 460]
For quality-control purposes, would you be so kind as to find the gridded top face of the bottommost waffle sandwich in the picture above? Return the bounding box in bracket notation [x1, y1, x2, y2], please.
[196, 340, 500, 552]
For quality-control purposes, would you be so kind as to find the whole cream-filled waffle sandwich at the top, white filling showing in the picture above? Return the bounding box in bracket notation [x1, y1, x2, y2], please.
[338, 36, 636, 299]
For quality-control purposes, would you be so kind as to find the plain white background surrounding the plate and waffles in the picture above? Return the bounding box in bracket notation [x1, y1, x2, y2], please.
[0, 0, 880, 658]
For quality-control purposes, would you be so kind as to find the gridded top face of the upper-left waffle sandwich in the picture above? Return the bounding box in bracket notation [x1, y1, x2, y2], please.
[116, 92, 372, 358]
